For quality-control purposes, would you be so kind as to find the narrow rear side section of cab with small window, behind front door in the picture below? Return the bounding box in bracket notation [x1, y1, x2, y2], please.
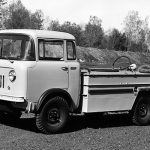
[66, 40, 80, 106]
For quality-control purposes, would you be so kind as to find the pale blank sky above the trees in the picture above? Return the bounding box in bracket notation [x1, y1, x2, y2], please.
[13, 0, 150, 30]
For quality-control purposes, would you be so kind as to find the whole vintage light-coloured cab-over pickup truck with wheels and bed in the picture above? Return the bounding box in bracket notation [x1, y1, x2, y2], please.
[0, 29, 150, 133]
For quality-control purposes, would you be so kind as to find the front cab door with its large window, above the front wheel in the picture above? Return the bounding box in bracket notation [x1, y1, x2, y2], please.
[28, 39, 69, 101]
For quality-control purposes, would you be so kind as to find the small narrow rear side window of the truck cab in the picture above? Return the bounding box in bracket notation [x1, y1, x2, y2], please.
[67, 41, 76, 60]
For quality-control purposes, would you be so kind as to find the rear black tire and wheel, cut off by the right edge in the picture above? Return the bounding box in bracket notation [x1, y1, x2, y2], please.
[132, 98, 150, 125]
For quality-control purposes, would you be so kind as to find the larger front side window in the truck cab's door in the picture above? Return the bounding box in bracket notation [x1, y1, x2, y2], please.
[39, 40, 64, 60]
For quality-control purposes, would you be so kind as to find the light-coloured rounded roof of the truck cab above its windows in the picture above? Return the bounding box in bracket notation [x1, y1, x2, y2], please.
[0, 29, 75, 40]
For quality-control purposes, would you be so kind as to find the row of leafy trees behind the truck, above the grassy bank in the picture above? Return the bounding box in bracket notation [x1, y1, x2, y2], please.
[0, 0, 150, 53]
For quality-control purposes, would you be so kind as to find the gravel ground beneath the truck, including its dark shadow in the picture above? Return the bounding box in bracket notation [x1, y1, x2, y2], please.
[0, 114, 150, 150]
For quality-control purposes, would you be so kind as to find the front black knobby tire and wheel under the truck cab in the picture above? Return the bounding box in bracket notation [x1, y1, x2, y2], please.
[36, 96, 69, 134]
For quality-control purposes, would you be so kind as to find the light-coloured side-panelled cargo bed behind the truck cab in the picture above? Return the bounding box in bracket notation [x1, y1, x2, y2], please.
[82, 68, 150, 113]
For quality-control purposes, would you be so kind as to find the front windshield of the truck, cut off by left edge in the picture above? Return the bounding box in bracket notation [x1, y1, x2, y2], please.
[0, 34, 35, 61]
